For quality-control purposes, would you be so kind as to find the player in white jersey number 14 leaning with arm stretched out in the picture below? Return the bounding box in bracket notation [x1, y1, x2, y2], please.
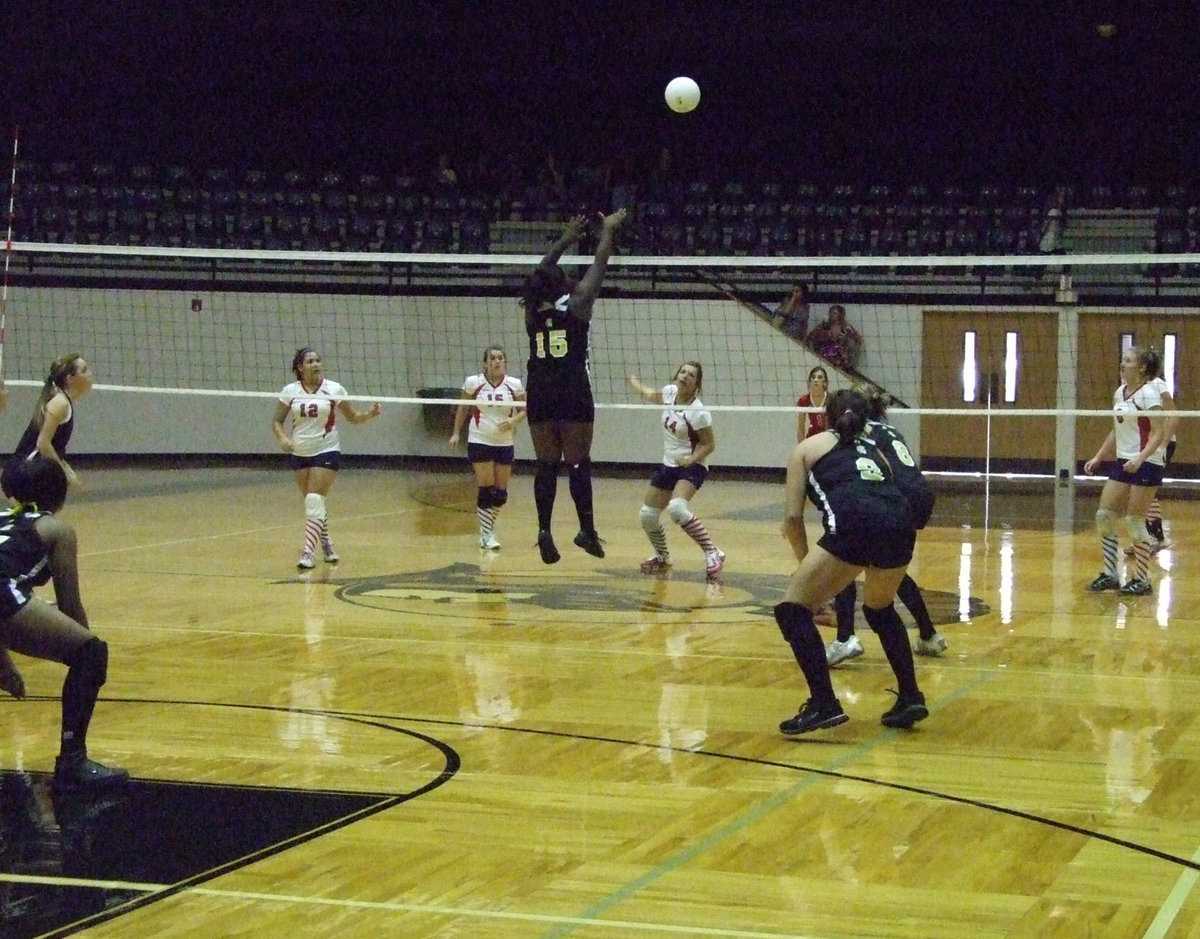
[628, 361, 725, 578]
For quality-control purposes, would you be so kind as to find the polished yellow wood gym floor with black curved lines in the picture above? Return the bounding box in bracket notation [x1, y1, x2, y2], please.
[0, 467, 1200, 939]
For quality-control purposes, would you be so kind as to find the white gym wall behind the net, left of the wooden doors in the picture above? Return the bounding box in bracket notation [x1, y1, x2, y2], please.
[0, 287, 925, 467]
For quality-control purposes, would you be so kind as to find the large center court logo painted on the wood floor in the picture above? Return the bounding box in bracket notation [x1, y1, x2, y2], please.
[286, 562, 989, 624]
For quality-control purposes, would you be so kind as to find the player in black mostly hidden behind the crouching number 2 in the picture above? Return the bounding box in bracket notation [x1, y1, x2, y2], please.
[826, 383, 949, 666]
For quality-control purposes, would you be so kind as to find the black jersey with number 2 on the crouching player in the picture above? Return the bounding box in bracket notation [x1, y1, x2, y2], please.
[808, 436, 914, 536]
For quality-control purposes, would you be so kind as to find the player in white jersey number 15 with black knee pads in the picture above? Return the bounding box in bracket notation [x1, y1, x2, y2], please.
[450, 346, 526, 551]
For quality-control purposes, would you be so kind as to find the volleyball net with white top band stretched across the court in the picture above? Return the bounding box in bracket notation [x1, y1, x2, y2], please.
[5, 244, 1200, 476]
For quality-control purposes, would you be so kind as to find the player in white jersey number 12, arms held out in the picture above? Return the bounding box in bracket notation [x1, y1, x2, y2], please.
[271, 346, 383, 570]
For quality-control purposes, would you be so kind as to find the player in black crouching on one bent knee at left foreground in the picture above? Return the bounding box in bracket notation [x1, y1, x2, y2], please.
[0, 454, 128, 788]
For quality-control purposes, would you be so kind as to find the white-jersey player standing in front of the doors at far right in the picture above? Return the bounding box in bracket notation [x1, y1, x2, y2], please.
[1084, 346, 1170, 597]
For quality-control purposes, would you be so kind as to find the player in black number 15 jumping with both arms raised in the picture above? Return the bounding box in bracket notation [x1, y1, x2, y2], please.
[521, 209, 625, 564]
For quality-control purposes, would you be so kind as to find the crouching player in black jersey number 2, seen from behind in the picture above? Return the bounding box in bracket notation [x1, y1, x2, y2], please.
[775, 389, 929, 735]
